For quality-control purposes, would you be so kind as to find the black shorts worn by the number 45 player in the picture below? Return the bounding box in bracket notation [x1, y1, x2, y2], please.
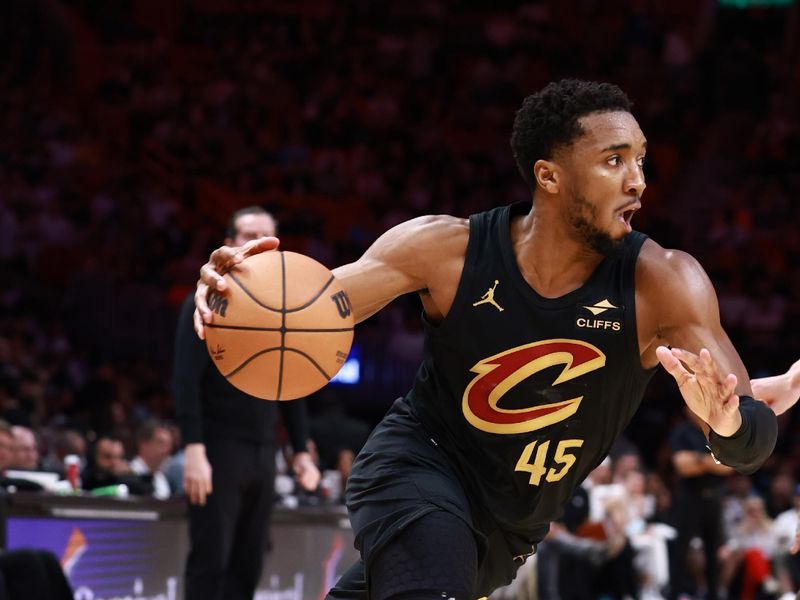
[338, 399, 546, 598]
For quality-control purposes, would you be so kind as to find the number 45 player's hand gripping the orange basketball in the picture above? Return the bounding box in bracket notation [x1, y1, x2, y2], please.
[194, 237, 280, 340]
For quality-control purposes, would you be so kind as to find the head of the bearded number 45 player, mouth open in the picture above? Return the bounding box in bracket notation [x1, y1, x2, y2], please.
[511, 79, 646, 254]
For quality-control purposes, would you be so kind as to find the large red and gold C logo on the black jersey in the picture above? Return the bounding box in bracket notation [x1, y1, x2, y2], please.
[461, 339, 606, 434]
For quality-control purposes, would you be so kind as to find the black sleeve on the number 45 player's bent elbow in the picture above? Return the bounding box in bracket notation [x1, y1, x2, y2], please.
[708, 396, 778, 475]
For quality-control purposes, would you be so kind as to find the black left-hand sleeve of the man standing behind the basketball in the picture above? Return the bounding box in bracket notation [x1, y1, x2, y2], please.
[172, 296, 212, 444]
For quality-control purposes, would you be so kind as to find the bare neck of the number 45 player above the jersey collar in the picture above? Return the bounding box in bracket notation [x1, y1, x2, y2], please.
[511, 208, 603, 298]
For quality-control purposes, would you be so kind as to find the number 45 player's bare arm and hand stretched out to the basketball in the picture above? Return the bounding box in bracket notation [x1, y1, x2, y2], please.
[194, 215, 469, 339]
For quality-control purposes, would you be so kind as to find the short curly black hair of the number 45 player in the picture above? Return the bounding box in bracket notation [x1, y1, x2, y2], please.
[511, 79, 633, 189]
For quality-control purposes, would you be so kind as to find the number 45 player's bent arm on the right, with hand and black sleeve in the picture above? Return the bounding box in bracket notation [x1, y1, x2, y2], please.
[636, 242, 777, 473]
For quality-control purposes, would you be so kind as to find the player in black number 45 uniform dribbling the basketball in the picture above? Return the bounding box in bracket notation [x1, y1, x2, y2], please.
[195, 80, 777, 600]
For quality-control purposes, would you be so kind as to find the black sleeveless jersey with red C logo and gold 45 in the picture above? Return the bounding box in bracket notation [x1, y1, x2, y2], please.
[405, 203, 652, 535]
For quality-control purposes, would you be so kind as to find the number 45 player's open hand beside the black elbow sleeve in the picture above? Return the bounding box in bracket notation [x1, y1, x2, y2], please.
[656, 346, 742, 437]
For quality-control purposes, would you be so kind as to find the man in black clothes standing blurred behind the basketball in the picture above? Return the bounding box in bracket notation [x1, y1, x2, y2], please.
[174, 207, 320, 600]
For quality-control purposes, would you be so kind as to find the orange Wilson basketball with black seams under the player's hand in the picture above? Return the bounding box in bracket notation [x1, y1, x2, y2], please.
[206, 251, 354, 400]
